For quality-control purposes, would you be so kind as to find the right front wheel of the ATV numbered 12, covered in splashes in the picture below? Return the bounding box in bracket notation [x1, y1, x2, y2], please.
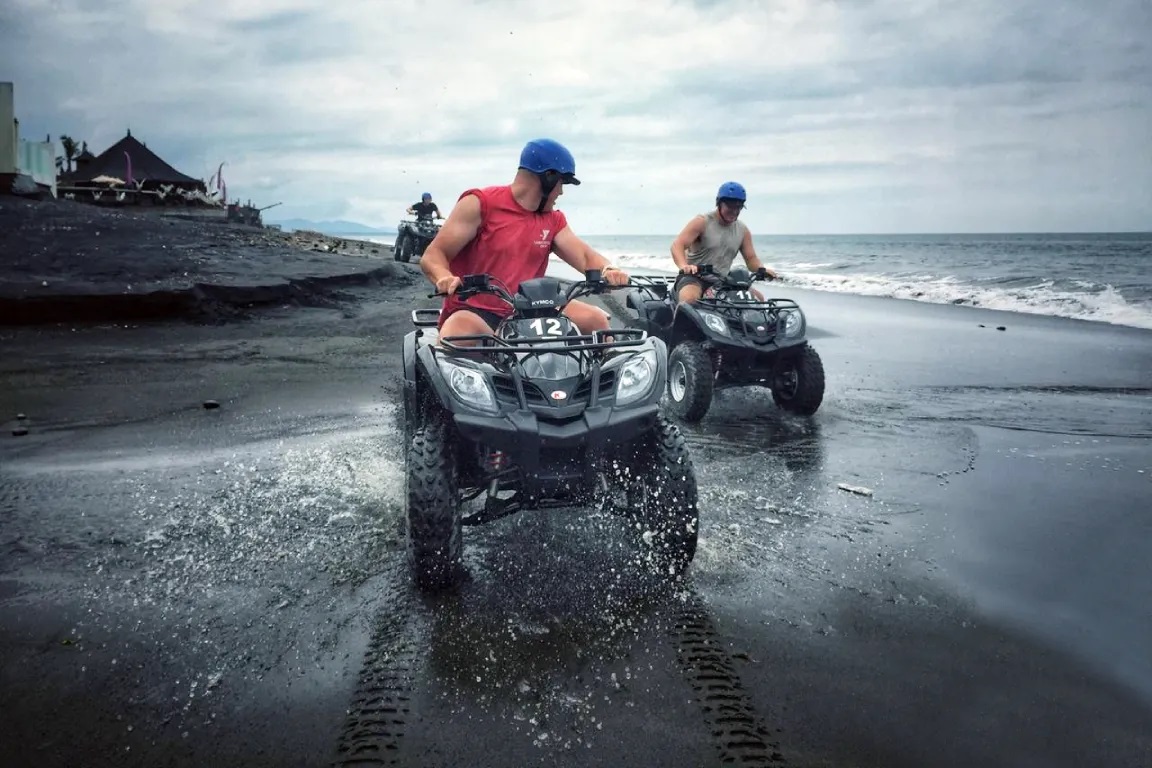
[627, 417, 699, 578]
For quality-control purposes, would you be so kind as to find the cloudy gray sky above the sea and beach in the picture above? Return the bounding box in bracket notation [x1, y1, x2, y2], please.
[0, 0, 1152, 235]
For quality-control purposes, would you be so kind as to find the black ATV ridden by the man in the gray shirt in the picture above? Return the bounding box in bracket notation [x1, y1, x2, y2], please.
[628, 265, 824, 423]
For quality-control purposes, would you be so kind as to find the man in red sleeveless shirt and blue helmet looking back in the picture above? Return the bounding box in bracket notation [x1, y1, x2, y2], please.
[420, 138, 628, 336]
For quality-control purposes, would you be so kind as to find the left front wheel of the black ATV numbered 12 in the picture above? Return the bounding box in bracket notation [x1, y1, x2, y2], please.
[404, 419, 464, 590]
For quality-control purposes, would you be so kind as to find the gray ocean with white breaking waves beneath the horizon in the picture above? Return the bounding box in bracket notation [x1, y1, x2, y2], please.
[340, 233, 1152, 329]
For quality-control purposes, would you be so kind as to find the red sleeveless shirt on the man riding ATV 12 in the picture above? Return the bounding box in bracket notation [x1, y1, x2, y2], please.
[440, 187, 568, 325]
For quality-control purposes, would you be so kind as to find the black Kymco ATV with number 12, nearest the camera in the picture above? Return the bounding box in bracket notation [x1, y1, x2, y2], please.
[403, 269, 698, 588]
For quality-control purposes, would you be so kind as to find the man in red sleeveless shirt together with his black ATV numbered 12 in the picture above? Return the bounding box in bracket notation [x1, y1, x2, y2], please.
[403, 139, 699, 590]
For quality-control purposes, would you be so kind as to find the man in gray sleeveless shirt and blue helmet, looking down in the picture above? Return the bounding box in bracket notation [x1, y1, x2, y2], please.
[672, 181, 776, 303]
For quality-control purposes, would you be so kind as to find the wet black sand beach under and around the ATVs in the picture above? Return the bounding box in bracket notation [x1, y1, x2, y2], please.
[0, 201, 1152, 768]
